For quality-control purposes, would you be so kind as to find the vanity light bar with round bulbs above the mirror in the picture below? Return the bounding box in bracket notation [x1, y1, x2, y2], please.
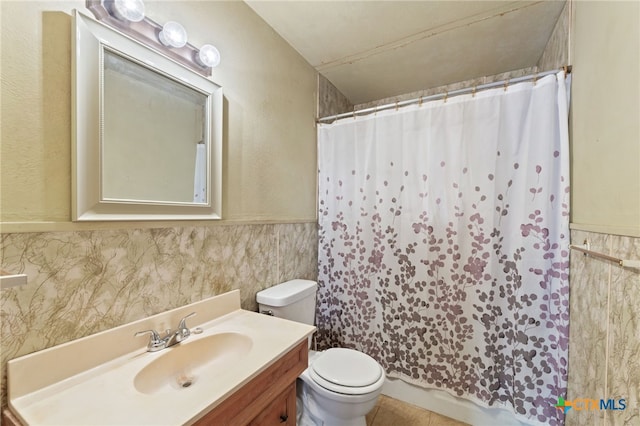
[86, 0, 220, 77]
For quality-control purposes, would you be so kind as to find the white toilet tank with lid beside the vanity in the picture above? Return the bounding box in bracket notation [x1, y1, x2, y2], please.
[256, 280, 318, 325]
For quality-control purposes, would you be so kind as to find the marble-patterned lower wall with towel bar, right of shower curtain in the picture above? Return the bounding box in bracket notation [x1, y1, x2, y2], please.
[566, 230, 640, 426]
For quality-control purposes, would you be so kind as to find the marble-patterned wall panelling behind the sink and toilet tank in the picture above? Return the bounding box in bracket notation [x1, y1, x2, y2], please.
[0, 223, 318, 406]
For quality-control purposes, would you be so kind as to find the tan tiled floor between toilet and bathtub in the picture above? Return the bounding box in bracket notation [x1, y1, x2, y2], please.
[367, 395, 466, 426]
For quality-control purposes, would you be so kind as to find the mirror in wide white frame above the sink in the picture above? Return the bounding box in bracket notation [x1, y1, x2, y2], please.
[72, 11, 223, 221]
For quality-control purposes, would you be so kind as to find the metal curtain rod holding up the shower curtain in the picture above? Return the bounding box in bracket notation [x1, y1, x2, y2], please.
[316, 65, 571, 123]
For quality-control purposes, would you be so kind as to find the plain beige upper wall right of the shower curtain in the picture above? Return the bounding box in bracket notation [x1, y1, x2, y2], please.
[571, 1, 640, 236]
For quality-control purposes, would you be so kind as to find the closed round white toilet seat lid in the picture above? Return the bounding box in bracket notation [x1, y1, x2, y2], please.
[309, 348, 384, 395]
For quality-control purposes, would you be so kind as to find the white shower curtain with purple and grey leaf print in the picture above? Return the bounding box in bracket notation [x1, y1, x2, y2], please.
[316, 73, 569, 425]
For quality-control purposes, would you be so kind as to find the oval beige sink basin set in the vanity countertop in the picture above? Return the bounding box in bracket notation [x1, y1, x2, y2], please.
[134, 333, 253, 394]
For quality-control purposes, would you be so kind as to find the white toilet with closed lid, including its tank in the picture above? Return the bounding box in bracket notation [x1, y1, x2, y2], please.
[256, 280, 385, 426]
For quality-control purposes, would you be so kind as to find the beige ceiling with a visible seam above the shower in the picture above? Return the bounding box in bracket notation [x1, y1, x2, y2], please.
[246, 0, 565, 104]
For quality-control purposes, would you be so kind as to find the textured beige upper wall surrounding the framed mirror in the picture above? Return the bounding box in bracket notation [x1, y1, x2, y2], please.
[0, 0, 316, 226]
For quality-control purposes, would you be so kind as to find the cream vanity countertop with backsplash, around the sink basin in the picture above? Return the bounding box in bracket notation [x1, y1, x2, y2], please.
[8, 291, 315, 426]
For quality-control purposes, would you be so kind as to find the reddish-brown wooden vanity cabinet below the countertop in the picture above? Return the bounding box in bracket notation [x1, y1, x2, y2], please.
[195, 339, 309, 426]
